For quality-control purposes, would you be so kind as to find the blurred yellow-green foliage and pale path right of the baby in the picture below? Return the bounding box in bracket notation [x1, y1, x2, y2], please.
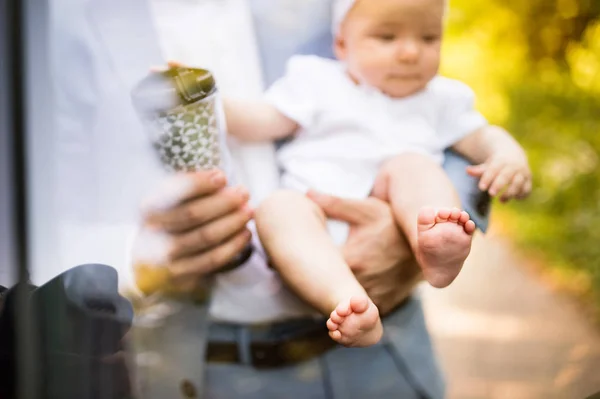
[423, 0, 600, 398]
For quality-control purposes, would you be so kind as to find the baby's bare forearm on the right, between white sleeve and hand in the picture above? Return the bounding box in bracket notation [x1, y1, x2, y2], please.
[452, 125, 525, 164]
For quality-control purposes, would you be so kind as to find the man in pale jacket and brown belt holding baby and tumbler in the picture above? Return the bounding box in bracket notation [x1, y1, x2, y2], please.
[51, 0, 486, 399]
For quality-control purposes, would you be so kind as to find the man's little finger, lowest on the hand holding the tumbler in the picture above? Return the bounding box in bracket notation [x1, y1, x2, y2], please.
[169, 229, 252, 279]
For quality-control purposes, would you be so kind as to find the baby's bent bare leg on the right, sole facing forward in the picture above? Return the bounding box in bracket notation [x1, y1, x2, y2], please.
[373, 154, 475, 288]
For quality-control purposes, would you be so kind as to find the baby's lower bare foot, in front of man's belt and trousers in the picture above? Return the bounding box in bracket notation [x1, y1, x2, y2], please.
[327, 295, 383, 347]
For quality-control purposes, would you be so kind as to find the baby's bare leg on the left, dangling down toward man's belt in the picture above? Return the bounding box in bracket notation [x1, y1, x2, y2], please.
[255, 191, 383, 346]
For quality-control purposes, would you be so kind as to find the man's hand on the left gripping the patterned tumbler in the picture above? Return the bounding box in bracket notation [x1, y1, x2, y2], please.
[144, 171, 252, 280]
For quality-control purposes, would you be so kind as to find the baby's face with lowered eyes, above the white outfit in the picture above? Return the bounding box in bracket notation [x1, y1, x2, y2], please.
[335, 0, 445, 98]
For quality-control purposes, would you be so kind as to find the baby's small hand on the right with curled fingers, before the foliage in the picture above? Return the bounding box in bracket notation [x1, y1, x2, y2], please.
[467, 152, 531, 202]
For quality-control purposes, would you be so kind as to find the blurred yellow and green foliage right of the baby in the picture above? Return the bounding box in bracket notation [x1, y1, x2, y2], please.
[442, 0, 600, 309]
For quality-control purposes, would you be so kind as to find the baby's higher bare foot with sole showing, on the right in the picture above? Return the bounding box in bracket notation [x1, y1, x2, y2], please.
[415, 208, 475, 288]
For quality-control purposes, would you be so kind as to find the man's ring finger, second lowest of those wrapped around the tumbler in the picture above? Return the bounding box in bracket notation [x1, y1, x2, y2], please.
[169, 207, 252, 260]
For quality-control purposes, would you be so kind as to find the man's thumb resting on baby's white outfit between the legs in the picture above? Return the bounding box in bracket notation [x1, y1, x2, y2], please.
[307, 191, 380, 224]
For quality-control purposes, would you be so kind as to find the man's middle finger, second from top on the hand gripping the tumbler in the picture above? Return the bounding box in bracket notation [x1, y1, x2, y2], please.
[148, 187, 249, 233]
